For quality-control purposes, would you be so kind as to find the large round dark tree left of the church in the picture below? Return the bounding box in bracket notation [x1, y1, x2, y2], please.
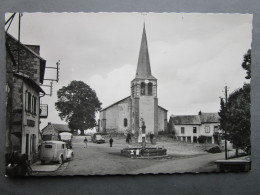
[55, 80, 101, 134]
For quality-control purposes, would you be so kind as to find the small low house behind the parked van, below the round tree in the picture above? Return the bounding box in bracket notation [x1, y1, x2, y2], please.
[41, 122, 71, 141]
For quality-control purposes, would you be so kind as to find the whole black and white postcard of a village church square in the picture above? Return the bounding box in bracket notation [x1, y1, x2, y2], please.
[5, 12, 253, 177]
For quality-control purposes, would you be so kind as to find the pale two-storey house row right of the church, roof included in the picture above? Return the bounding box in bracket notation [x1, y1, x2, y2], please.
[169, 112, 220, 143]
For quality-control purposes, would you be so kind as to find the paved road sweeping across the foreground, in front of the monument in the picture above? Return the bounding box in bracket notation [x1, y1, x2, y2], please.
[47, 139, 228, 175]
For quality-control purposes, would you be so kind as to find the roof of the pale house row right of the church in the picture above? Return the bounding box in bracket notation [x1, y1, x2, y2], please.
[171, 112, 219, 125]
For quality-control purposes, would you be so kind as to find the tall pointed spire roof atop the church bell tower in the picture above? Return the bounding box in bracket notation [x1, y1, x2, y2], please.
[135, 25, 156, 79]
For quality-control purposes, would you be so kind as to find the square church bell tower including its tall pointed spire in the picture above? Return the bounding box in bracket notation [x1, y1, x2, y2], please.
[131, 25, 158, 135]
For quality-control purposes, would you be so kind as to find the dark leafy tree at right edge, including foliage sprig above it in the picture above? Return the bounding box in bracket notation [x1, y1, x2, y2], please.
[219, 49, 251, 153]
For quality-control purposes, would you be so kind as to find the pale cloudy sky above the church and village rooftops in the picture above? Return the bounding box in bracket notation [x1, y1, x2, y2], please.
[6, 13, 253, 129]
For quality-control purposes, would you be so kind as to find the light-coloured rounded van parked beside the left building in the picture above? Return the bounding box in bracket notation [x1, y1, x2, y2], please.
[40, 141, 74, 164]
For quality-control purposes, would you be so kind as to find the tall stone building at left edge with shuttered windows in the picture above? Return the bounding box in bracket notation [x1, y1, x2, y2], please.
[5, 33, 46, 162]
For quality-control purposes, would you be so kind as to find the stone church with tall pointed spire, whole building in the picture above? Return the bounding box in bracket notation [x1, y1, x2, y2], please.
[98, 25, 167, 135]
